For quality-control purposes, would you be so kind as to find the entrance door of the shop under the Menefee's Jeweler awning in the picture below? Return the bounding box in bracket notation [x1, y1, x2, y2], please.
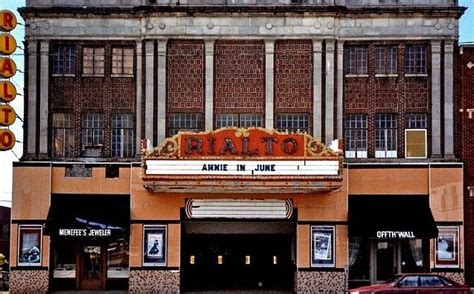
[79, 244, 107, 290]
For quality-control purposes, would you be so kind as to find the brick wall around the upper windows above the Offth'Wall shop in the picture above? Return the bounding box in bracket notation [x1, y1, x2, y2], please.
[344, 42, 431, 158]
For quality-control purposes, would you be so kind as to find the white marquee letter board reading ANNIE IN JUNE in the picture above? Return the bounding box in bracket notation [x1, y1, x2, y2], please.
[146, 160, 339, 176]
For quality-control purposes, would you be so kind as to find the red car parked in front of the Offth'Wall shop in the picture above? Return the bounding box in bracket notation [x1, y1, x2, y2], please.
[349, 273, 471, 294]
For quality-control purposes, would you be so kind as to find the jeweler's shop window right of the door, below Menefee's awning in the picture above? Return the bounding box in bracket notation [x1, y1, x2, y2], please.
[107, 238, 130, 279]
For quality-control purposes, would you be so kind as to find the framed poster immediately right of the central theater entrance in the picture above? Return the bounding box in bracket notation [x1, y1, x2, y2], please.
[311, 226, 334, 267]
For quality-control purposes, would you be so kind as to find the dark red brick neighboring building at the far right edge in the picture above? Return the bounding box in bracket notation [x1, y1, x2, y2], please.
[458, 44, 474, 285]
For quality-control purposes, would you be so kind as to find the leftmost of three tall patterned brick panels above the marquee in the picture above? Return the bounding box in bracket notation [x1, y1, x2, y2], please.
[166, 40, 205, 113]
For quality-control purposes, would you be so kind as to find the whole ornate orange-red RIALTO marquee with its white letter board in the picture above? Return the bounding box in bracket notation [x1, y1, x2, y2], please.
[142, 128, 342, 193]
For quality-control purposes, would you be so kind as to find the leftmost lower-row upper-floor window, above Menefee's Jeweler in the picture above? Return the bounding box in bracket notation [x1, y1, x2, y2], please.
[52, 113, 74, 157]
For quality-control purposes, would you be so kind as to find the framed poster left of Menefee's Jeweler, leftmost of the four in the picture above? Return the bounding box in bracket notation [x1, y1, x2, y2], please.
[18, 225, 43, 266]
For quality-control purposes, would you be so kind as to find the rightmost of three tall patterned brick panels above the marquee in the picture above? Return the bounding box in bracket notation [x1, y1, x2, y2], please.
[274, 40, 313, 113]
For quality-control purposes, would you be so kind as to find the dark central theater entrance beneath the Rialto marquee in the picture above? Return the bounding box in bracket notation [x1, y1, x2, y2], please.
[181, 223, 295, 291]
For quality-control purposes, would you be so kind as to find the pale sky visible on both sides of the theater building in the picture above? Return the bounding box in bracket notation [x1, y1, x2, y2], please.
[0, 0, 474, 207]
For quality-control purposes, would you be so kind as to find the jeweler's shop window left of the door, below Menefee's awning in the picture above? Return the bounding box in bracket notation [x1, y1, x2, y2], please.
[53, 242, 76, 279]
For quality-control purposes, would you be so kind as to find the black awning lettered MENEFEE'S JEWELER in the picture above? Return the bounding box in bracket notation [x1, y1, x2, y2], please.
[45, 195, 130, 238]
